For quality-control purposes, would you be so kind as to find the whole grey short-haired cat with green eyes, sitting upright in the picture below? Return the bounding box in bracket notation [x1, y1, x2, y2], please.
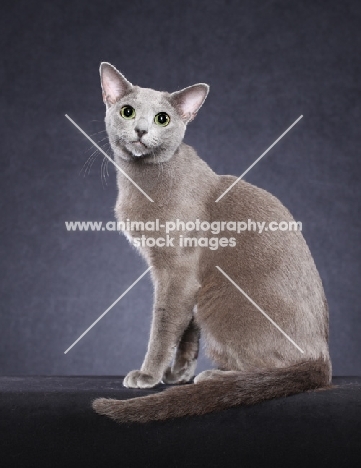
[92, 62, 331, 423]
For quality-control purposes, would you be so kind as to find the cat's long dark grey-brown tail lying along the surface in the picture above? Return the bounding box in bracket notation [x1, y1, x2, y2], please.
[93, 358, 331, 423]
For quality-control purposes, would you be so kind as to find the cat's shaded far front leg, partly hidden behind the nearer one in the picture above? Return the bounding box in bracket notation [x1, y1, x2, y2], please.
[162, 319, 200, 384]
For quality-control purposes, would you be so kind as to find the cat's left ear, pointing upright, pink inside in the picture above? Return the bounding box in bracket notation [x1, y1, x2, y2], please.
[99, 62, 133, 107]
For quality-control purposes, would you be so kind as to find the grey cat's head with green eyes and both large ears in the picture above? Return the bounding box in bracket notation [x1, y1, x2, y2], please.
[100, 62, 209, 164]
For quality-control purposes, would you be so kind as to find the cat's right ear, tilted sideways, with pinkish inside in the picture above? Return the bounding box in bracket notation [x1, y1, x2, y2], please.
[170, 83, 209, 123]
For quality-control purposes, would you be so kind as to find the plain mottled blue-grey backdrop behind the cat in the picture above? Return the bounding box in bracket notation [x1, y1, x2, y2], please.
[0, 0, 361, 375]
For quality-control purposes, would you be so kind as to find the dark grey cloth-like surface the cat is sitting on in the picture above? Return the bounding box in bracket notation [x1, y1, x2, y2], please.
[0, 376, 361, 468]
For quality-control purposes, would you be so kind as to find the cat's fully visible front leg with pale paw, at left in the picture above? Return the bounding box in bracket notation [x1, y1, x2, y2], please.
[123, 265, 199, 388]
